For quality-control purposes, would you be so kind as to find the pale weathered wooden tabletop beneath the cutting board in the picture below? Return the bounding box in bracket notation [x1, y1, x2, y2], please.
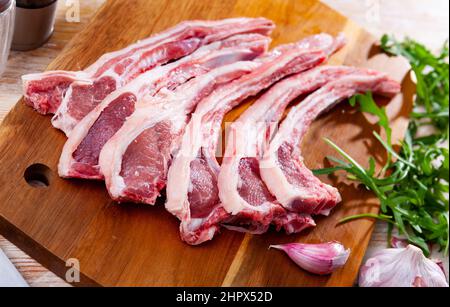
[0, 0, 449, 286]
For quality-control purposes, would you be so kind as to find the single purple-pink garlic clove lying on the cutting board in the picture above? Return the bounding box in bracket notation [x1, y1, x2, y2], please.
[269, 242, 350, 275]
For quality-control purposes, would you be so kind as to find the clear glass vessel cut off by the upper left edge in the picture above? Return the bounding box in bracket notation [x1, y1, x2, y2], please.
[0, 0, 16, 76]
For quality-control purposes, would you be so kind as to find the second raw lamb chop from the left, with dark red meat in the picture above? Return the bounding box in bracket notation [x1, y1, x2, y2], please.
[58, 34, 270, 179]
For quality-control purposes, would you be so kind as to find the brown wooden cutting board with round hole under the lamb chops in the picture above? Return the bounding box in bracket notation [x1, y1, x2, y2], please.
[0, 0, 414, 286]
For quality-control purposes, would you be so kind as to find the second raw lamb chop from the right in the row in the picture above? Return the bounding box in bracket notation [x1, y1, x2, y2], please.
[218, 66, 358, 233]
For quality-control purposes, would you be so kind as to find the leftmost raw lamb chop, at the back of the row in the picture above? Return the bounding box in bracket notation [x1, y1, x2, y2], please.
[23, 18, 274, 134]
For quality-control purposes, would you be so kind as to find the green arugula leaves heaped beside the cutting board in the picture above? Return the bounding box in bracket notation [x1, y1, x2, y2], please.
[314, 35, 449, 255]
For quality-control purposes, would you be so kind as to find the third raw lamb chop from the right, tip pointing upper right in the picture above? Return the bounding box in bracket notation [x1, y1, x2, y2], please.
[166, 34, 343, 244]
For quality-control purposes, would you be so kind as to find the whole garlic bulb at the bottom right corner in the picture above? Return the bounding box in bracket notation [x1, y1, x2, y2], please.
[359, 245, 448, 287]
